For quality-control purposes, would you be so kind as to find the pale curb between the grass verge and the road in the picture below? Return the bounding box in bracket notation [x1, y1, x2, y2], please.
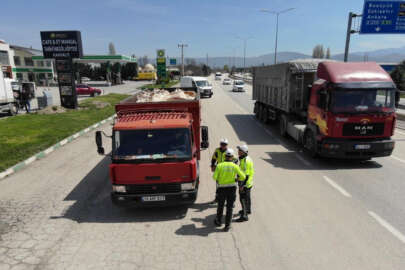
[0, 114, 115, 180]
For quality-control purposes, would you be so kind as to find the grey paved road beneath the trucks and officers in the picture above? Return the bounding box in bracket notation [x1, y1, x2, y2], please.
[0, 74, 405, 270]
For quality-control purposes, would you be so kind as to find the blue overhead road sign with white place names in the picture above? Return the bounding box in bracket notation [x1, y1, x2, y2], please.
[360, 0, 405, 34]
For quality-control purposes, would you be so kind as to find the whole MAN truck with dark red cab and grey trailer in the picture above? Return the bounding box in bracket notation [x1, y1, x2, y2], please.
[253, 59, 396, 160]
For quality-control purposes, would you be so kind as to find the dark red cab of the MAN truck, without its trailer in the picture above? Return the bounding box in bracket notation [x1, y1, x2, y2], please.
[304, 62, 396, 159]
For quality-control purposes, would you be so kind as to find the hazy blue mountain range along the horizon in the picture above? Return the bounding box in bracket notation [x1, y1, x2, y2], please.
[181, 47, 405, 67]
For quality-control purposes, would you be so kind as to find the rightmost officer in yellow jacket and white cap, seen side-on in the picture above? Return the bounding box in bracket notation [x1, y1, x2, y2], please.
[237, 144, 255, 222]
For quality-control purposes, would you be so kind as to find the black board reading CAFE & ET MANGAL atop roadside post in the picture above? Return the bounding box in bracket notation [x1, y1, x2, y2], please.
[41, 31, 83, 58]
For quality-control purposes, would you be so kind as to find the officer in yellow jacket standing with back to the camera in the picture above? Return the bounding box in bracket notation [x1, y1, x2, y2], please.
[214, 149, 245, 231]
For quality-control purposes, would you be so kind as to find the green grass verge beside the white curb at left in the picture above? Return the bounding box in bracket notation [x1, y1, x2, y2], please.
[0, 94, 128, 172]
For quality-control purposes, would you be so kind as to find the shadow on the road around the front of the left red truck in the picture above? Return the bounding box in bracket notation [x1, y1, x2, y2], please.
[51, 157, 188, 223]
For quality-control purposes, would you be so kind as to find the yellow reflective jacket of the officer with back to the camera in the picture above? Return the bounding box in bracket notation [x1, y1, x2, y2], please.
[213, 161, 246, 188]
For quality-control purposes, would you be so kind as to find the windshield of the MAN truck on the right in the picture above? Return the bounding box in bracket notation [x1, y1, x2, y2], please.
[331, 88, 395, 114]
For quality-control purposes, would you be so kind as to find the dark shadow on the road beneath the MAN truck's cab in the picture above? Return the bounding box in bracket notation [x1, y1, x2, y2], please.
[263, 152, 382, 170]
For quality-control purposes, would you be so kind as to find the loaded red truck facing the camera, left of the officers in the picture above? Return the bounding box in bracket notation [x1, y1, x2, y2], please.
[96, 88, 209, 206]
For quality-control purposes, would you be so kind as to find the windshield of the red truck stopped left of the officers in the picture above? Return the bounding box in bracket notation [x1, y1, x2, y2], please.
[113, 128, 191, 160]
